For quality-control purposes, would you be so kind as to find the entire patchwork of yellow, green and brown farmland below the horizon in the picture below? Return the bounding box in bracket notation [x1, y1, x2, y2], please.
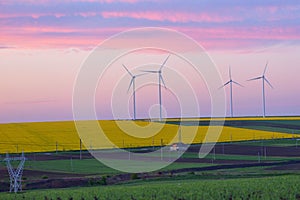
[0, 117, 300, 200]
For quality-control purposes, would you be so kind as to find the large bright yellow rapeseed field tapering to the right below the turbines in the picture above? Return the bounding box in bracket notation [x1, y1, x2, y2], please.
[0, 120, 297, 153]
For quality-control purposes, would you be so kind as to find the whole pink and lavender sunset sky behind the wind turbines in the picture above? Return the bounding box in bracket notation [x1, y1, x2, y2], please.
[0, 0, 300, 123]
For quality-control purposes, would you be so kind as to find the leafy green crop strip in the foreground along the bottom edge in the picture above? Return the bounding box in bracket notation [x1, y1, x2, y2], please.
[0, 175, 300, 200]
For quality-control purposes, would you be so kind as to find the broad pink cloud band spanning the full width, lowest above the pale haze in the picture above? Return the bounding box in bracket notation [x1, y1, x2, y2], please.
[0, 23, 300, 49]
